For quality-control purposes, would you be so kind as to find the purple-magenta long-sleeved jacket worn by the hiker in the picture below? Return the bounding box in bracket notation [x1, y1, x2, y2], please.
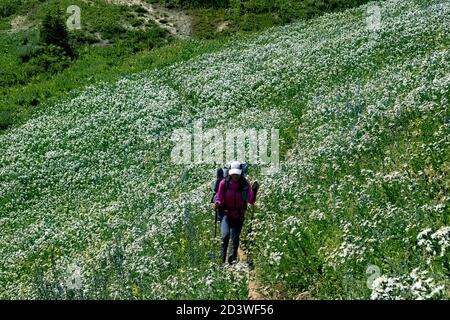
[216, 179, 256, 218]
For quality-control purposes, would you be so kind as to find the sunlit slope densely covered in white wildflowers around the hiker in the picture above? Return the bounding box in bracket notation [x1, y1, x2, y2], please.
[0, 0, 450, 299]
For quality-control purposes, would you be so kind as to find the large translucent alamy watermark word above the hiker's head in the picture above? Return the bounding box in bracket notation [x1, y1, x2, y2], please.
[171, 121, 280, 175]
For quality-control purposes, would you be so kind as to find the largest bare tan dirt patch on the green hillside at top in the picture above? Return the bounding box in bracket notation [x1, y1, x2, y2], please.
[108, 0, 194, 39]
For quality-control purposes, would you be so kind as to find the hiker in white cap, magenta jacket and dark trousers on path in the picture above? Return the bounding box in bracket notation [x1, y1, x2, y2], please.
[215, 161, 256, 264]
